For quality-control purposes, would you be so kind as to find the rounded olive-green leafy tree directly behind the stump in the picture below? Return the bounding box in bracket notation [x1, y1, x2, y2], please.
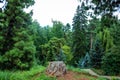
[41, 37, 65, 62]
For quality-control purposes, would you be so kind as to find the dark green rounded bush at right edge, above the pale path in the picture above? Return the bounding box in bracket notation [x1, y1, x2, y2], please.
[102, 46, 120, 75]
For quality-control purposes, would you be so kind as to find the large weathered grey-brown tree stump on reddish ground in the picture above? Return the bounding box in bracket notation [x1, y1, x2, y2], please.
[46, 61, 67, 77]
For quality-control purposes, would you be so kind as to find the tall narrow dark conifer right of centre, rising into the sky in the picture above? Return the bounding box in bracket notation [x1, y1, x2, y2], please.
[73, 3, 87, 66]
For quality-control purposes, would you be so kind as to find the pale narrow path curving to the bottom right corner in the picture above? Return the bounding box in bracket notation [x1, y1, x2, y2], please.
[82, 69, 120, 80]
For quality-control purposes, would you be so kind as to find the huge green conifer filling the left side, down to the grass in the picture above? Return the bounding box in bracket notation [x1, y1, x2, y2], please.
[0, 0, 36, 69]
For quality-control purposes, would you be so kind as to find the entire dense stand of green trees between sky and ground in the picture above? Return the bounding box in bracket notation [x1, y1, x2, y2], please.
[0, 0, 120, 79]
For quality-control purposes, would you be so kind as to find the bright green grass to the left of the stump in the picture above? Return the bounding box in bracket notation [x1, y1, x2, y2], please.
[0, 66, 54, 80]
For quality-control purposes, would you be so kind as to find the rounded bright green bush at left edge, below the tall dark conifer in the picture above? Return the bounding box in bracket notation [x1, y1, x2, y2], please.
[0, 41, 36, 70]
